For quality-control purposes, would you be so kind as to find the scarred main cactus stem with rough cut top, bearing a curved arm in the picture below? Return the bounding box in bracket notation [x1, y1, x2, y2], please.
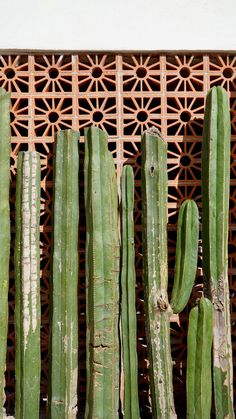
[141, 131, 176, 418]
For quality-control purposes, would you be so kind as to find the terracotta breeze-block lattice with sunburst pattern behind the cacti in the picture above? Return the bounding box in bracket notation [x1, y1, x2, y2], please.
[3, 53, 236, 418]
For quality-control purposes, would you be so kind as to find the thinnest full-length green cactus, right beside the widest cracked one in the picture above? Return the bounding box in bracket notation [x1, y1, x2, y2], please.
[121, 166, 139, 419]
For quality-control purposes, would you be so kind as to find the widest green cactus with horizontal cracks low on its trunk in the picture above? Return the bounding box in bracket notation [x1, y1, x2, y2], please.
[85, 127, 119, 419]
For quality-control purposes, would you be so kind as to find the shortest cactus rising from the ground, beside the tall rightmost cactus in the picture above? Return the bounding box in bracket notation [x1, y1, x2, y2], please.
[187, 297, 213, 419]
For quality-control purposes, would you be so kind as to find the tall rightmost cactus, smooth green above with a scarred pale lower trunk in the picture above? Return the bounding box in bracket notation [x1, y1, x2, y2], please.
[202, 86, 234, 419]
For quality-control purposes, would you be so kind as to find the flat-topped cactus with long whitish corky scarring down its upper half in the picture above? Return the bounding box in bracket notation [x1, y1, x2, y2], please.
[15, 152, 41, 419]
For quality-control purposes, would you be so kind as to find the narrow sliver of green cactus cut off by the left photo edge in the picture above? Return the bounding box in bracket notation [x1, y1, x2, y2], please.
[0, 88, 10, 419]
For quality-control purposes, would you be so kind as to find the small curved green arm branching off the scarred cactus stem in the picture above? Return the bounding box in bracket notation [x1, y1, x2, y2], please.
[171, 199, 199, 313]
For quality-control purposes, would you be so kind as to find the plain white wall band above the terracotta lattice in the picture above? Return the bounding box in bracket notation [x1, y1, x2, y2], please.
[0, 0, 236, 51]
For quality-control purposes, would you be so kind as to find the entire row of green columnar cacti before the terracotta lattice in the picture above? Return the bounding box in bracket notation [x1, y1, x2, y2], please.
[0, 83, 234, 419]
